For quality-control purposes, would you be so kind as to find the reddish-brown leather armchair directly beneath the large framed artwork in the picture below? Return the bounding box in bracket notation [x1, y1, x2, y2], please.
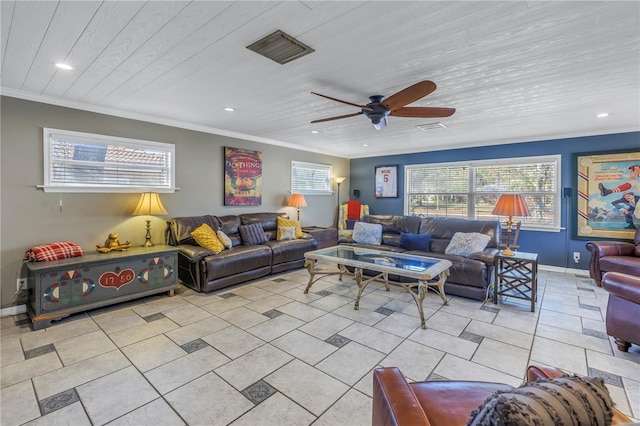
[585, 229, 640, 287]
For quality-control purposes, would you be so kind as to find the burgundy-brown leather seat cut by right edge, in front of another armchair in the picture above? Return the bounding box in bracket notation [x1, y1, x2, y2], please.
[602, 272, 640, 352]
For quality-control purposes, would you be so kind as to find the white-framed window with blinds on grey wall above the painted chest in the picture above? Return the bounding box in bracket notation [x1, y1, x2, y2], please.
[43, 128, 175, 192]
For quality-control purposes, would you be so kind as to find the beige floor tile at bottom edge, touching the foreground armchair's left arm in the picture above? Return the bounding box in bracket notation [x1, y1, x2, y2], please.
[313, 389, 373, 426]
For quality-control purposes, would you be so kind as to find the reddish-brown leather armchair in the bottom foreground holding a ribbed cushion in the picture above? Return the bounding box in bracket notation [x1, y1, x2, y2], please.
[372, 366, 631, 426]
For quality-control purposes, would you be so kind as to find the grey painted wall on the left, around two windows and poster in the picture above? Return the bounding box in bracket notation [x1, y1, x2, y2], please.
[0, 96, 349, 308]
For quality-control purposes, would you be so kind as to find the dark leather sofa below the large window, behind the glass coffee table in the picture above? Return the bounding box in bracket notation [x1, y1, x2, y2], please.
[340, 215, 501, 300]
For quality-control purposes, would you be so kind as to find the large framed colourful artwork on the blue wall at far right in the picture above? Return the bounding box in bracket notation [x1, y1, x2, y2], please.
[573, 150, 640, 240]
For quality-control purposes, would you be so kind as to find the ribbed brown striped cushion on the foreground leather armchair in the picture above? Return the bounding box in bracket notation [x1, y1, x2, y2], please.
[467, 375, 613, 426]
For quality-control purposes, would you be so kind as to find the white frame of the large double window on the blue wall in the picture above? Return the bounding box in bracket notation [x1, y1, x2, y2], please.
[403, 154, 562, 232]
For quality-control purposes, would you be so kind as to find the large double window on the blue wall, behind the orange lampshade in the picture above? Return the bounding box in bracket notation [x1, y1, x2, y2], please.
[404, 155, 560, 230]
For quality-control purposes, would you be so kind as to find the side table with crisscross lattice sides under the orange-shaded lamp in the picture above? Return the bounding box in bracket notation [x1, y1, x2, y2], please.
[493, 252, 538, 312]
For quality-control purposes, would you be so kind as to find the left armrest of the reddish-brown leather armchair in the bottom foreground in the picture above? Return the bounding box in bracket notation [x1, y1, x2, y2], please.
[372, 367, 429, 426]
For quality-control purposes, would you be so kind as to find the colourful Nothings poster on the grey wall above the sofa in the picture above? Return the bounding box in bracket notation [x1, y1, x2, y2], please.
[224, 147, 262, 206]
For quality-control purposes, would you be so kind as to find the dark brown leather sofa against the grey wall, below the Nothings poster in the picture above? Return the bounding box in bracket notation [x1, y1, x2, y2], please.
[165, 213, 318, 292]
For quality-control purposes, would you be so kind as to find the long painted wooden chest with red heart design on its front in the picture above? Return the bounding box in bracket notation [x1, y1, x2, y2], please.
[27, 245, 178, 330]
